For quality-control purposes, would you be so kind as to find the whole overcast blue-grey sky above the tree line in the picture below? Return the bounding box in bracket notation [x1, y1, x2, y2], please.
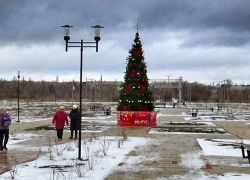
[0, 0, 250, 84]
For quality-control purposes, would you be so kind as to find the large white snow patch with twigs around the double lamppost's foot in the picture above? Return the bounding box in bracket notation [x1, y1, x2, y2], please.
[1, 137, 147, 180]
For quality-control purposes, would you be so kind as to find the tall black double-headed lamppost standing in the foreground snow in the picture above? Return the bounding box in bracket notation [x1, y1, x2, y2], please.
[61, 25, 104, 160]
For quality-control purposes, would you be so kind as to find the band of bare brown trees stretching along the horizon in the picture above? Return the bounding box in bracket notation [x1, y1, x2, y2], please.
[0, 78, 249, 103]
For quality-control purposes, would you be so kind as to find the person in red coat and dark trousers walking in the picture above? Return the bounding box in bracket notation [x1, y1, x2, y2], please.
[52, 106, 69, 139]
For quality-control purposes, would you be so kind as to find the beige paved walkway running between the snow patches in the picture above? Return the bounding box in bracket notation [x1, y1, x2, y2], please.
[0, 109, 250, 180]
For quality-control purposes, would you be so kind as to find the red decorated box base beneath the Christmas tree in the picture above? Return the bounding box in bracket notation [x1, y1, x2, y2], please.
[117, 111, 157, 126]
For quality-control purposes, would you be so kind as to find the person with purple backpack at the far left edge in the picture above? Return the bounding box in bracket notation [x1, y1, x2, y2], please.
[0, 106, 10, 151]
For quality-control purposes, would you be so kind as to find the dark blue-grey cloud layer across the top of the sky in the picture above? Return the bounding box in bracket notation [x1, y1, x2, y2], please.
[0, 0, 250, 43]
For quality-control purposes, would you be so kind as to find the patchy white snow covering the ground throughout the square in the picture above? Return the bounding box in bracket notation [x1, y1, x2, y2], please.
[0, 103, 250, 180]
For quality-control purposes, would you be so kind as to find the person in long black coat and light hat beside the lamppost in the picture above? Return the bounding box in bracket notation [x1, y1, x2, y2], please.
[69, 105, 81, 139]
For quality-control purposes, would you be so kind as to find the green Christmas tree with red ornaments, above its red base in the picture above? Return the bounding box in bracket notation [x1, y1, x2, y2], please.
[117, 31, 154, 111]
